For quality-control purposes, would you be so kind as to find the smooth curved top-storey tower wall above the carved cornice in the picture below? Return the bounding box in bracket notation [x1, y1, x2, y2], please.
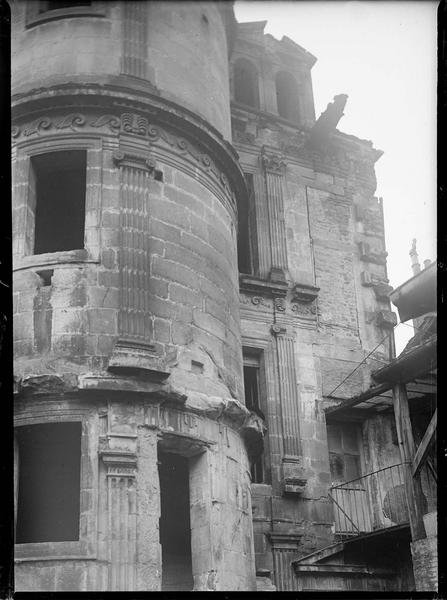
[12, 0, 231, 139]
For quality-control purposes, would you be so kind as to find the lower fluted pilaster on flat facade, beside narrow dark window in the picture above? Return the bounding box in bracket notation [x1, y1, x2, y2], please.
[272, 325, 306, 493]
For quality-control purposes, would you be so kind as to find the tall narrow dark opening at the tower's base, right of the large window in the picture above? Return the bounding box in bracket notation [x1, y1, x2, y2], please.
[158, 453, 193, 591]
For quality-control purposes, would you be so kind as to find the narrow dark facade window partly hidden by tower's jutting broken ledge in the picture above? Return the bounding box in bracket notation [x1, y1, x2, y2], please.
[243, 349, 268, 483]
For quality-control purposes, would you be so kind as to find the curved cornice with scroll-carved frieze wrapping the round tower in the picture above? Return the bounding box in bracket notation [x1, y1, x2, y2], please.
[12, 81, 248, 215]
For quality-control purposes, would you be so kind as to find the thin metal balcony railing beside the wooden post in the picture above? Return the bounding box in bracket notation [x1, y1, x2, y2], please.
[329, 464, 408, 535]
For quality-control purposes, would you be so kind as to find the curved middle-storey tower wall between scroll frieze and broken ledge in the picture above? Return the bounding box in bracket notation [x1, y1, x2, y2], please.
[13, 102, 242, 399]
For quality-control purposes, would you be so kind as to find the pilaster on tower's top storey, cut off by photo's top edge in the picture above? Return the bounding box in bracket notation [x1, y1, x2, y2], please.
[121, 0, 147, 79]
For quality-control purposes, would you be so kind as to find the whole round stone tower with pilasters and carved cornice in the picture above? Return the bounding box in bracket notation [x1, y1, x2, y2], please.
[12, 0, 262, 591]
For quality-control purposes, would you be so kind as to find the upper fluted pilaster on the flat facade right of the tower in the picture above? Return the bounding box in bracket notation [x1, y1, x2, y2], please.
[261, 151, 287, 281]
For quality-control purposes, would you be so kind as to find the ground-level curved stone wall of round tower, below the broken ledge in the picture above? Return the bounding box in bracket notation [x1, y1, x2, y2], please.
[15, 393, 255, 591]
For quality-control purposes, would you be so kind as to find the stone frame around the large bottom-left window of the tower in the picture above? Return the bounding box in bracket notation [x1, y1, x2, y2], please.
[14, 408, 98, 564]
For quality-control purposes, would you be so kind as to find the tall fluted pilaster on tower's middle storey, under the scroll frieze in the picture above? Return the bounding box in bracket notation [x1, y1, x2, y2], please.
[113, 151, 155, 348]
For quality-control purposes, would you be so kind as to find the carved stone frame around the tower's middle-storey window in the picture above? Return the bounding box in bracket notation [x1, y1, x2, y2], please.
[13, 136, 102, 271]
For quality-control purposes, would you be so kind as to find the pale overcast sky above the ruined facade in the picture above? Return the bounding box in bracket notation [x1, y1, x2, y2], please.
[235, 0, 438, 352]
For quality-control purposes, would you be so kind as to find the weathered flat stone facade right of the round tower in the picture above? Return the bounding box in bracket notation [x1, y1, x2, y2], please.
[232, 24, 390, 590]
